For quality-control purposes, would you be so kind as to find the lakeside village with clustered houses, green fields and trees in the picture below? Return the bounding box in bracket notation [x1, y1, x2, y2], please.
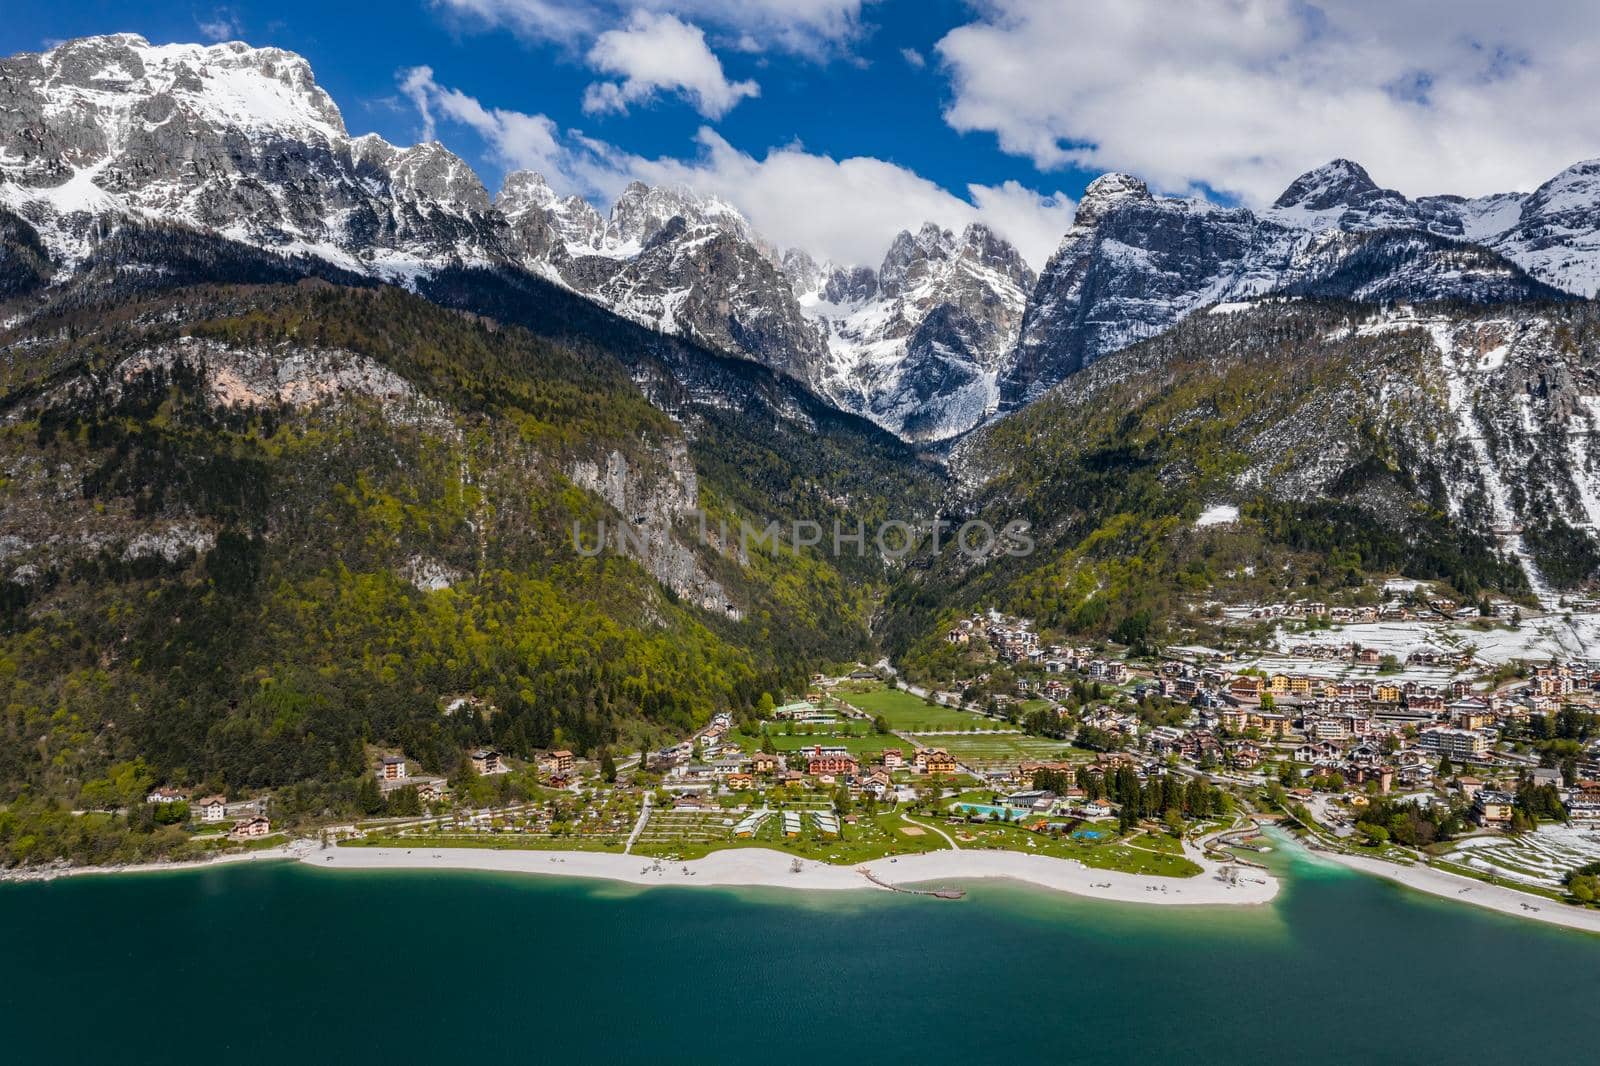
[121, 585, 1600, 898]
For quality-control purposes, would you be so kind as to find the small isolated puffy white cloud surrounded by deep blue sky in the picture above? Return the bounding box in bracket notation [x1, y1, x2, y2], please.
[584, 11, 760, 118]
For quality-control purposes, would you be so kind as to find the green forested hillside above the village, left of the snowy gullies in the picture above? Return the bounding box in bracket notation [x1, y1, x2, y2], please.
[888, 304, 1528, 664]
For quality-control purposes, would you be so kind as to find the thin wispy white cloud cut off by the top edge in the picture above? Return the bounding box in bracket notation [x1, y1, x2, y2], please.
[434, 0, 872, 58]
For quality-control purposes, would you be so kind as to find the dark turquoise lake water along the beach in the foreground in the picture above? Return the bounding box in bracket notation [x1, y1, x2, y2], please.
[0, 855, 1600, 1066]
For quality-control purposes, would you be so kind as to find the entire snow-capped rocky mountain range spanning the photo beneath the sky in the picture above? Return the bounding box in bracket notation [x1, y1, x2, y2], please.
[0, 35, 1600, 442]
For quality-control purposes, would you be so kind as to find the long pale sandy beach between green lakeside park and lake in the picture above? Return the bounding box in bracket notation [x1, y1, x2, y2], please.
[302, 847, 1278, 906]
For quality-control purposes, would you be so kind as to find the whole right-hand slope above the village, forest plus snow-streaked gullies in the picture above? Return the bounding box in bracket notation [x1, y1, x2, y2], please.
[918, 298, 1600, 627]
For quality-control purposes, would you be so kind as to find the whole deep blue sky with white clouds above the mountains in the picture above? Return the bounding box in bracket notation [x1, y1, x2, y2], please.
[0, 0, 1600, 267]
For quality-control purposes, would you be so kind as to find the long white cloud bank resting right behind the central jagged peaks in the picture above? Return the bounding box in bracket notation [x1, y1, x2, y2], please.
[400, 67, 1072, 269]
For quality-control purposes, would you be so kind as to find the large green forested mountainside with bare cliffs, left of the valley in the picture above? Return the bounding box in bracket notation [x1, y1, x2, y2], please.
[0, 282, 928, 853]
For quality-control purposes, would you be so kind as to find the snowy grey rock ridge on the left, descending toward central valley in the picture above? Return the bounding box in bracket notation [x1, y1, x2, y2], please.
[0, 35, 824, 379]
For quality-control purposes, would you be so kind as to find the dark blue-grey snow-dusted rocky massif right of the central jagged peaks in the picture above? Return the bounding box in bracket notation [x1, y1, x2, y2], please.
[1000, 160, 1574, 407]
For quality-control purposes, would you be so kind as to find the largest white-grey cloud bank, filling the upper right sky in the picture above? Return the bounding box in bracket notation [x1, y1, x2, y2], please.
[938, 0, 1600, 203]
